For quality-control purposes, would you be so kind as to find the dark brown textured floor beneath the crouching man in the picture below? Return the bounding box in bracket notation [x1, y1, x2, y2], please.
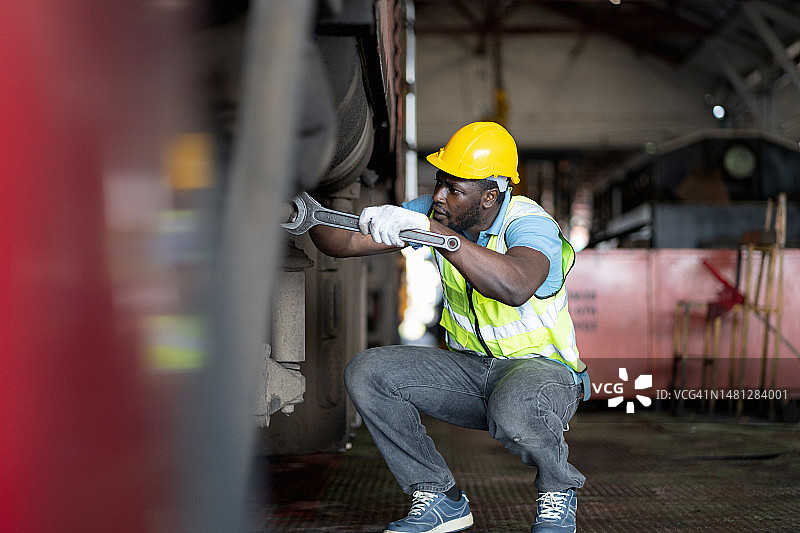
[249, 410, 800, 533]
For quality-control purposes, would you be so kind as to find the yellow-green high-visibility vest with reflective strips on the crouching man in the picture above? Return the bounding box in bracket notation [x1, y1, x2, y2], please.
[434, 196, 586, 372]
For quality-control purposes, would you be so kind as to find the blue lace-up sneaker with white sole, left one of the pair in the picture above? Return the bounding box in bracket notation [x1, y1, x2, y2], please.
[383, 490, 472, 533]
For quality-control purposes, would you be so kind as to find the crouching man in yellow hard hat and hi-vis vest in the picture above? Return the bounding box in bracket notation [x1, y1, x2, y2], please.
[311, 122, 590, 533]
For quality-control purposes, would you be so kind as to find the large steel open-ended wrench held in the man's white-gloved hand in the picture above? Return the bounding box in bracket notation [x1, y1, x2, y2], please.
[281, 192, 461, 252]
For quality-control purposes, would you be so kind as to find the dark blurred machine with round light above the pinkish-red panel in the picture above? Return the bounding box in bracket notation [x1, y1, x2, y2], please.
[592, 129, 800, 248]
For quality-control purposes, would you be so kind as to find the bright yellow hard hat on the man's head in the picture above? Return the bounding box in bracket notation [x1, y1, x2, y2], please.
[427, 122, 519, 184]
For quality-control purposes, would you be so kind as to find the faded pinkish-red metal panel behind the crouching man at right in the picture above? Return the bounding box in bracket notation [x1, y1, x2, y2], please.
[567, 249, 800, 398]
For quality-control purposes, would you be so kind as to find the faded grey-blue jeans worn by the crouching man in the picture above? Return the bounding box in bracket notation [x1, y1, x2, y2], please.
[345, 346, 586, 494]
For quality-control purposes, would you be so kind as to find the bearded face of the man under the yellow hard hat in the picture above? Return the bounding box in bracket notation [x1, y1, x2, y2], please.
[433, 170, 483, 232]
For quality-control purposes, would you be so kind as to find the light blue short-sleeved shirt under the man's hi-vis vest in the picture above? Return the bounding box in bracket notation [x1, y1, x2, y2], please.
[403, 193, 563, 298]
